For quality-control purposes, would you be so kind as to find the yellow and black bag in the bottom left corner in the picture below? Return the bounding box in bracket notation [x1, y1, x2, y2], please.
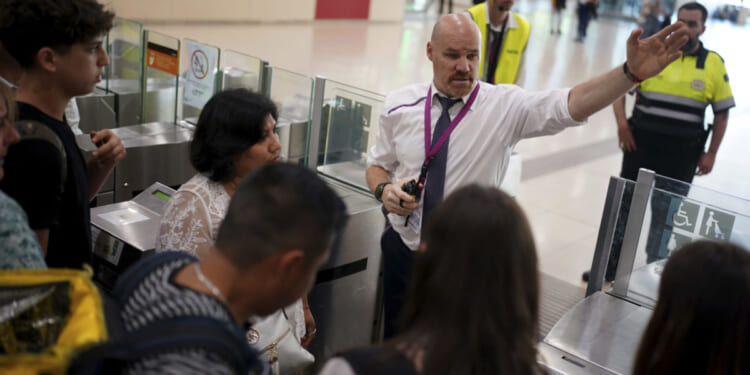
[0, 269, 108, 375]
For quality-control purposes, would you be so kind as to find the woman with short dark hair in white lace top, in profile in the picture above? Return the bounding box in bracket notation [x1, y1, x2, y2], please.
[156, 89, 315, 374]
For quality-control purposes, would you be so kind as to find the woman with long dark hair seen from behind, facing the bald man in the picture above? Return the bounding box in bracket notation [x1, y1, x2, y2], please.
[321, 185, 543, 375]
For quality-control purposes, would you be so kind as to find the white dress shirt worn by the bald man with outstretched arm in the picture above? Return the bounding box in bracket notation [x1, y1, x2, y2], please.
[367, 81, 585, 250]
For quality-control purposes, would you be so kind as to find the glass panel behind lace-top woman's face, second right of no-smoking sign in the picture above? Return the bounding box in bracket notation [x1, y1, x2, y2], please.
[270, 68, 313, 165]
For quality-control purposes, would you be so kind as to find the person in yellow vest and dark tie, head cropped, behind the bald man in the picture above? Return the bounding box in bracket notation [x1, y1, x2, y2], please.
[467, 0, 531, 84]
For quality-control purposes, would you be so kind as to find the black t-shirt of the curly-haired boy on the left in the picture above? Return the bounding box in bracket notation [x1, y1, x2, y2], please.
[0, 102, 91, 268]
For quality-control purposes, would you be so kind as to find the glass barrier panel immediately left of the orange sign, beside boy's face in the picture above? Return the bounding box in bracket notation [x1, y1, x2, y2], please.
[104, 18, 144, 126]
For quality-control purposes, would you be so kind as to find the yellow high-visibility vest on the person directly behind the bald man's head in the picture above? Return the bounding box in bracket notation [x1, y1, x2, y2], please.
[468, 3, 531, 83]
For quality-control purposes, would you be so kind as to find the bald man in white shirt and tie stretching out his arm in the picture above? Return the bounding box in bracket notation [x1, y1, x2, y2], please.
[367, 14, 687, 337]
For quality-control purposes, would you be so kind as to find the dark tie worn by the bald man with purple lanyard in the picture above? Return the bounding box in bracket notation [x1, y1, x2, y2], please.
[422, 95, 461, 227]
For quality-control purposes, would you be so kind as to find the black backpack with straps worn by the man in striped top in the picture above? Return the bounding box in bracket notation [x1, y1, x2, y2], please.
[68, 252, 264, 375]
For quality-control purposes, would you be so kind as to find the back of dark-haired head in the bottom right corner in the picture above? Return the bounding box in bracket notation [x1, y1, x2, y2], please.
[633, 241, 750, 375]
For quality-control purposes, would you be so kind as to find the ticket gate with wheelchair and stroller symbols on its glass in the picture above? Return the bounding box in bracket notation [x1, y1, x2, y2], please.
[539, 169, 750, 375]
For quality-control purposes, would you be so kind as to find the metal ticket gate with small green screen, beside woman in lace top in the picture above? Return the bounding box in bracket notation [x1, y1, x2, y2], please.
[91, 182, 175, 288]
